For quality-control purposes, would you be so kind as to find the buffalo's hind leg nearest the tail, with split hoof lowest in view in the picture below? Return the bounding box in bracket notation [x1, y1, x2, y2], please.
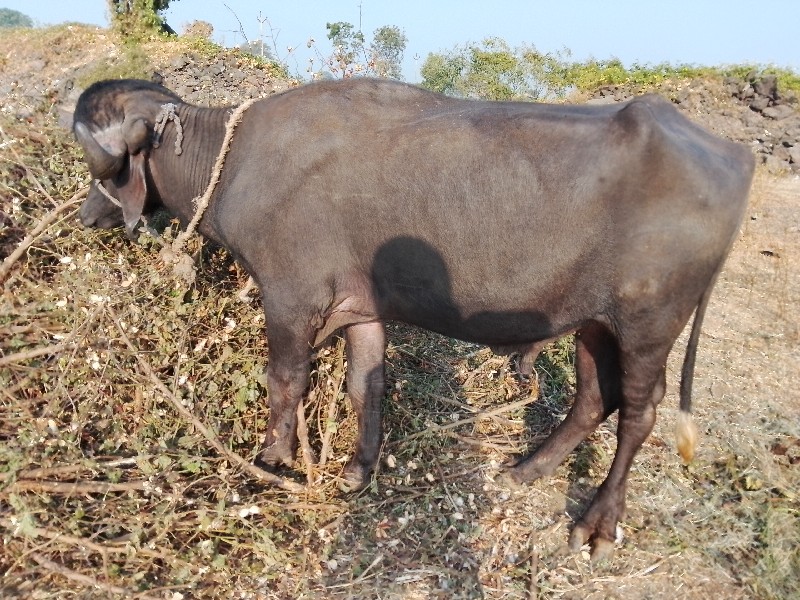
[569, 345, 669, 561]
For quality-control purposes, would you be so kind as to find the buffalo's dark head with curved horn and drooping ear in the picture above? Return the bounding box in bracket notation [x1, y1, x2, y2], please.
[73, 80, 180, 235]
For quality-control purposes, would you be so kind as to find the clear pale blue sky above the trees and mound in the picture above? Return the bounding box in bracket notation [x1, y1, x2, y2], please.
[0, 0, 800, 82]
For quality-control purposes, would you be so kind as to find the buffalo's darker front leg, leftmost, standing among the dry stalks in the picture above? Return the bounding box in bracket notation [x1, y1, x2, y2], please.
[257, 333, 311, 470]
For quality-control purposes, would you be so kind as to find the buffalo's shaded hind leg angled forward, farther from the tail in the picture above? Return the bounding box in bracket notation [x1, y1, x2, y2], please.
[501, 323, 620, 487]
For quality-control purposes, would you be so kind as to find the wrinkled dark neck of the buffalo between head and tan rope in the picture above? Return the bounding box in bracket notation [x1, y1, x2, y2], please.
[149, 104, 233, 242]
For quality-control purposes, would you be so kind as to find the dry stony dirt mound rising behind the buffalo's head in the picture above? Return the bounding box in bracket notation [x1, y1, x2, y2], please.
[0, 25, 297, 127]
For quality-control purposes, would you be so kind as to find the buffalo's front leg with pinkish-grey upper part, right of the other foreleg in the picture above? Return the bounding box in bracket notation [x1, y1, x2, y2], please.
[343, 321, 386, 490]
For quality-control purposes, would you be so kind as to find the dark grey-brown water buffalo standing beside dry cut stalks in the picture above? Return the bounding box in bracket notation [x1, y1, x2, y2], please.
[74, 79, 754, 557]
